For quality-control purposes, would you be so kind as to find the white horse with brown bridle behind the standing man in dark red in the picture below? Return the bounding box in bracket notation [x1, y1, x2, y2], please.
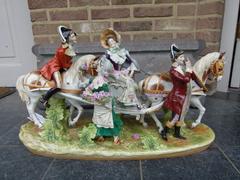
[139, 52, 224, 132]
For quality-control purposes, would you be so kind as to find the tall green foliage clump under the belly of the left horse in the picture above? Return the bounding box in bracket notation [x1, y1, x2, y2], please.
[40, 98, 69, 142]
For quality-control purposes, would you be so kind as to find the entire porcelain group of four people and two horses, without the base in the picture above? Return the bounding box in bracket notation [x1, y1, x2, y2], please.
[16, 26, 224, 144]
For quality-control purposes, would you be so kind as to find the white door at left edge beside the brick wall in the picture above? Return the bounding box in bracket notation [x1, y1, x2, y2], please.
[0, 0, 37, 87]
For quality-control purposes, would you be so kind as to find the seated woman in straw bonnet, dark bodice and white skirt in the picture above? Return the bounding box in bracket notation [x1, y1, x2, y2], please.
[100, 29, 141, 107]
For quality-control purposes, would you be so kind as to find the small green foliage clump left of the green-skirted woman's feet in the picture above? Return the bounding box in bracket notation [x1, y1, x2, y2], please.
[78, 123, 97, 147]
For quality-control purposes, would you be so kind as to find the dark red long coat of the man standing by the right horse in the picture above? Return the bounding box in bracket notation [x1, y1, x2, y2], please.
[163, 67, 196, 115]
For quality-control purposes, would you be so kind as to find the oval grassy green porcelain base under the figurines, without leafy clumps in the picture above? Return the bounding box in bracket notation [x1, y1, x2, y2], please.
[19, 119, 215, 160]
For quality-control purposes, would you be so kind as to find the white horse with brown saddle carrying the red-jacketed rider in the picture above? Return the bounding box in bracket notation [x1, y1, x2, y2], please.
[16, 55, 96, 128]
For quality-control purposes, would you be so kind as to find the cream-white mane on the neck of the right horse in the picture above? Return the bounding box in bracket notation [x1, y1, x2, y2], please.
[193, 52, 220, 79]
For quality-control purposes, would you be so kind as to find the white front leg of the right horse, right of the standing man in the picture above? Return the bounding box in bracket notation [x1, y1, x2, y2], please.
[191, 96, 206, 128]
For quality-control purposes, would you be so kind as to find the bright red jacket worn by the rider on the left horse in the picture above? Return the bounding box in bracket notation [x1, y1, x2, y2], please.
[40, 47, 72, 80]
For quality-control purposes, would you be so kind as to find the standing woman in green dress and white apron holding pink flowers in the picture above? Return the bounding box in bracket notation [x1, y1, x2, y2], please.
[83, 61, 123, 144]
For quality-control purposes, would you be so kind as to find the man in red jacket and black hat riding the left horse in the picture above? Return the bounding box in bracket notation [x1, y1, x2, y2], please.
[39, 26, 77, 106]
